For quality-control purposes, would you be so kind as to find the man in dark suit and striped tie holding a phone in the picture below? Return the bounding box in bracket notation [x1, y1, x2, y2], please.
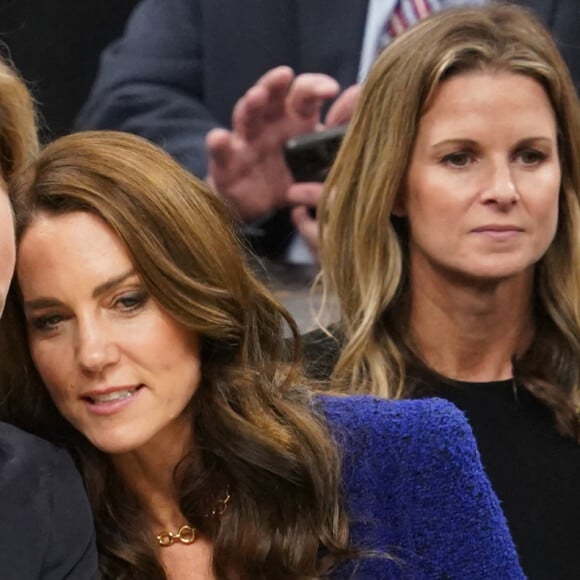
[76, 0, 536, 262]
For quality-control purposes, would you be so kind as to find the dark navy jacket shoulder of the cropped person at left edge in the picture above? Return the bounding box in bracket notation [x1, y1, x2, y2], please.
[0, 423, 97, 580]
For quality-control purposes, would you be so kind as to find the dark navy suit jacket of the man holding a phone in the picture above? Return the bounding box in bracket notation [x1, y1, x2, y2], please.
[77, 0, 580, 255]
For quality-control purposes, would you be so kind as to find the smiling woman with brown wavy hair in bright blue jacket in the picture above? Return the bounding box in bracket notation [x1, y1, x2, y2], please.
[0, 132, 523, 580]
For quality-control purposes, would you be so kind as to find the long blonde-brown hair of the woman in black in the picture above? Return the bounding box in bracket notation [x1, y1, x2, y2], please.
[321, 5, 580, 436]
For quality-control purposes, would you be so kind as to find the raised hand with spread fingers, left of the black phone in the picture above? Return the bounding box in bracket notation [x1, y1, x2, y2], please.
[206, 67, 339, 221]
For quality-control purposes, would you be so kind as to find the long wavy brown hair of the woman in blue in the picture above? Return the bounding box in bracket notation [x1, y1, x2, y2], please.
[0, 132, 348, 580]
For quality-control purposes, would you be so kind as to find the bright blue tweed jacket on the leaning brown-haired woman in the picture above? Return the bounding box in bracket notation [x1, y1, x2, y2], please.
[317, 396, 525, 580]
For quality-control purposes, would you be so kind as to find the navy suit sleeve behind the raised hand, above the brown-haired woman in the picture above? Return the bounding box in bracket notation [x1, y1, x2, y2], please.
[76, 0, 218, 178]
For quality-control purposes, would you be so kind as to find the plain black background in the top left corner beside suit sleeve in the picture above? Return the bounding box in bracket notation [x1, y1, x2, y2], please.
[0, 0, 137, 141]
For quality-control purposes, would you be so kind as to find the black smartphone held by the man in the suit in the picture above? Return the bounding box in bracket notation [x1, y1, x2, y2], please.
[284, 125, 346, 182]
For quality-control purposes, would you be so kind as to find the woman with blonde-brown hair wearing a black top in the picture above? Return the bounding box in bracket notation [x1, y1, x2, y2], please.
[306, 6, 580, 580]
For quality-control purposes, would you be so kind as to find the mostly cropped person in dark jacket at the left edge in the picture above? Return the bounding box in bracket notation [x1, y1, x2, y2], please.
[0, 53, 97, 580]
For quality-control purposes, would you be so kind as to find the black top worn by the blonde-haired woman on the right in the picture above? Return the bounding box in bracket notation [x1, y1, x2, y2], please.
[304, 331, 580, 580]
